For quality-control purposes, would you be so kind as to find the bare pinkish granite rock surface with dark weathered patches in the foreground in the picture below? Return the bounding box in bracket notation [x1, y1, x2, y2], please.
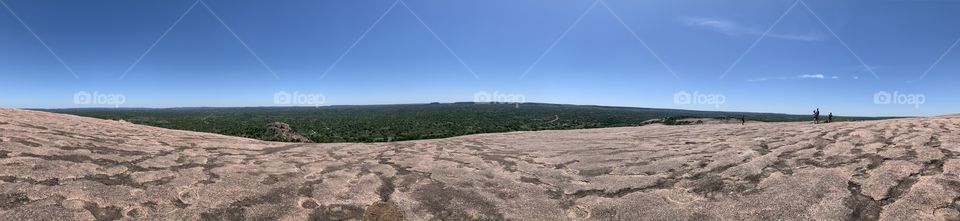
[0, 109, 960, 220]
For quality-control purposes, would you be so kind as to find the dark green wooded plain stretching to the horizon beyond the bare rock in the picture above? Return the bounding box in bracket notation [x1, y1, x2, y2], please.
[42, 102, 881, 143]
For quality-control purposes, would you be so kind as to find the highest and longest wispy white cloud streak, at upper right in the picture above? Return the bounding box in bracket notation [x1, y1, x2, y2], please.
[680, 17, 824, 41]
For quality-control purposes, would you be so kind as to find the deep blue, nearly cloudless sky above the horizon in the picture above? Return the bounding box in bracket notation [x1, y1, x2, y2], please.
[0, 0, 960, 116]
